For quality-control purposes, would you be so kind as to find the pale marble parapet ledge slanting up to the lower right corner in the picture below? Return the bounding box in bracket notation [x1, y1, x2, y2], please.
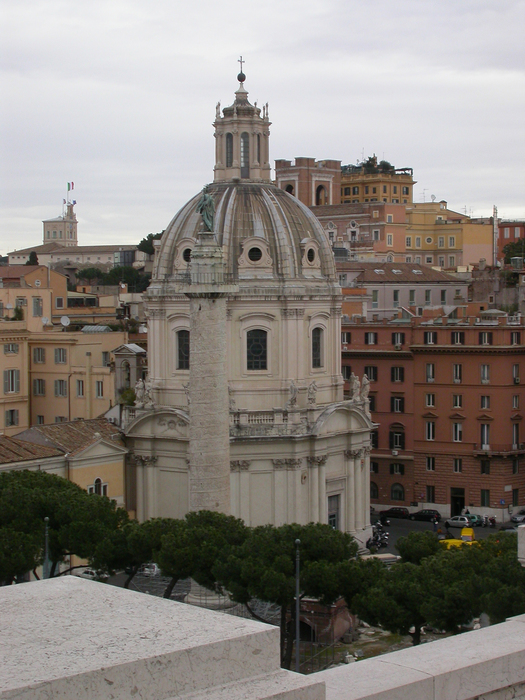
[316, 615, 525, 700]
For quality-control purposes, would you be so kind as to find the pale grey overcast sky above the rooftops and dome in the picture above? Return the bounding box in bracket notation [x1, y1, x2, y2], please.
[0, 0, 525, 253]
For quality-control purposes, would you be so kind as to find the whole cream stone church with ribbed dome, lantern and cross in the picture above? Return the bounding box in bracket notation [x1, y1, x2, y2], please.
[125, 65, 374, 542]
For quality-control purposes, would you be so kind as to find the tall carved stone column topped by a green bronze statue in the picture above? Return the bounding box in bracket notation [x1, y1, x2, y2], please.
[184, 187, 237, 514]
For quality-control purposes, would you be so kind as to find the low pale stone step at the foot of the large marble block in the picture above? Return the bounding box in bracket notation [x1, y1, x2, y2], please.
[176, 670, 326, 700]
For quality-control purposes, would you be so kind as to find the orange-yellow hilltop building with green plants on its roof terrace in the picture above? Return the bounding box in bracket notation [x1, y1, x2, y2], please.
[341, 155, 416, 204]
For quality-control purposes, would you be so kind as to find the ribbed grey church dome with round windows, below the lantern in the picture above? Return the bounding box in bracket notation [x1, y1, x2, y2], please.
[153, 180, 336, 282]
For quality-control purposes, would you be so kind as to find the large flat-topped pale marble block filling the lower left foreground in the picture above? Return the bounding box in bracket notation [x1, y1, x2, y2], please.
[0, 576, 324, 700]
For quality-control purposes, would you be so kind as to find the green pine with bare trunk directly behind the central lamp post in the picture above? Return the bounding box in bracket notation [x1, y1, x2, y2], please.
[214, 523, 357, 668]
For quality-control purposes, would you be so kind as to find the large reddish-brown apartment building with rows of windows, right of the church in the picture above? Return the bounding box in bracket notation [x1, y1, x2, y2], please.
[341, 308, 525, 520]
